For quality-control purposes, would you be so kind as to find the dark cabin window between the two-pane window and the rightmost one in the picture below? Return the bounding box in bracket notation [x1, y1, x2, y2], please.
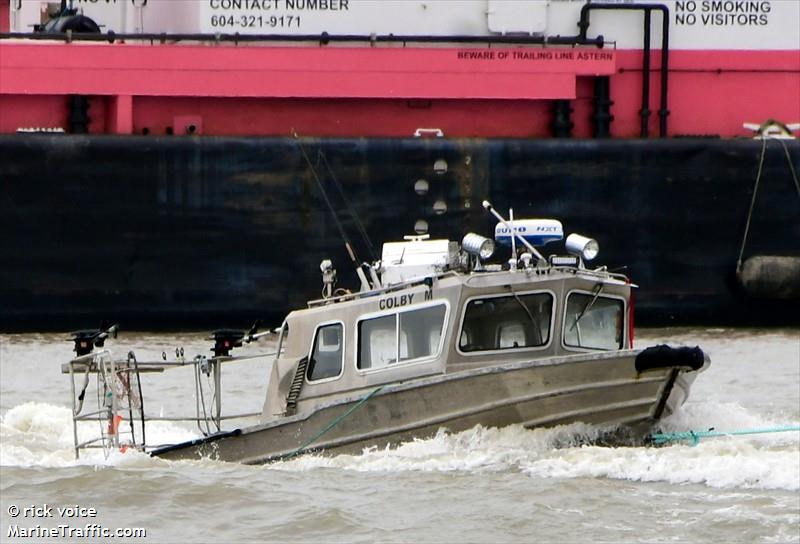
[458, 293, 553, 352]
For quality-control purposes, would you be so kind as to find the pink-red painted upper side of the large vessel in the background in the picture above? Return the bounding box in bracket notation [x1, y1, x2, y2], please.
[0, 42, 800, 138]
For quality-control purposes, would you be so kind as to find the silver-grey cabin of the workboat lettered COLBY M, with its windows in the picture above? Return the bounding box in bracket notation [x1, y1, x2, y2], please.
[262, 212, 632, 422]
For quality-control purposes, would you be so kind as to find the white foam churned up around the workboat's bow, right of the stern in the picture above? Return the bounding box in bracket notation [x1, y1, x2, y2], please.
[274, 403, 800, 491]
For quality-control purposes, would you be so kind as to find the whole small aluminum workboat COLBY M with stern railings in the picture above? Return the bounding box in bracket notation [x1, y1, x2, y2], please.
[64, 202, 709, 463]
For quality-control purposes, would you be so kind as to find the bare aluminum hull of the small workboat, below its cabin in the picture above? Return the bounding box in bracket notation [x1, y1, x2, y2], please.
[153, 350, 708, 464]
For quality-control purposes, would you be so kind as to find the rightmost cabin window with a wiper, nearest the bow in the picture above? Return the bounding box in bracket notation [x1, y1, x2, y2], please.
[564, 293, 625, 350]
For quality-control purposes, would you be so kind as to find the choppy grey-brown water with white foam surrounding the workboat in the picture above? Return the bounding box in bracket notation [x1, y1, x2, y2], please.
[0, 329, 800, 543]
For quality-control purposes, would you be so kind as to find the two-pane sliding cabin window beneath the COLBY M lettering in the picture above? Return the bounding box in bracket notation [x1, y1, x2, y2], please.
[357, 304, 447, 370]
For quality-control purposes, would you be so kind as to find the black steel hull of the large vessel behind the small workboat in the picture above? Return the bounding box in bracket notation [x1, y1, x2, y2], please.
[0, 135, 800, 330]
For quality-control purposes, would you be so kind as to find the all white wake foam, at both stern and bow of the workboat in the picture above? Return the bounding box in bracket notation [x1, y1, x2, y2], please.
[0, 402, 800, 491]
